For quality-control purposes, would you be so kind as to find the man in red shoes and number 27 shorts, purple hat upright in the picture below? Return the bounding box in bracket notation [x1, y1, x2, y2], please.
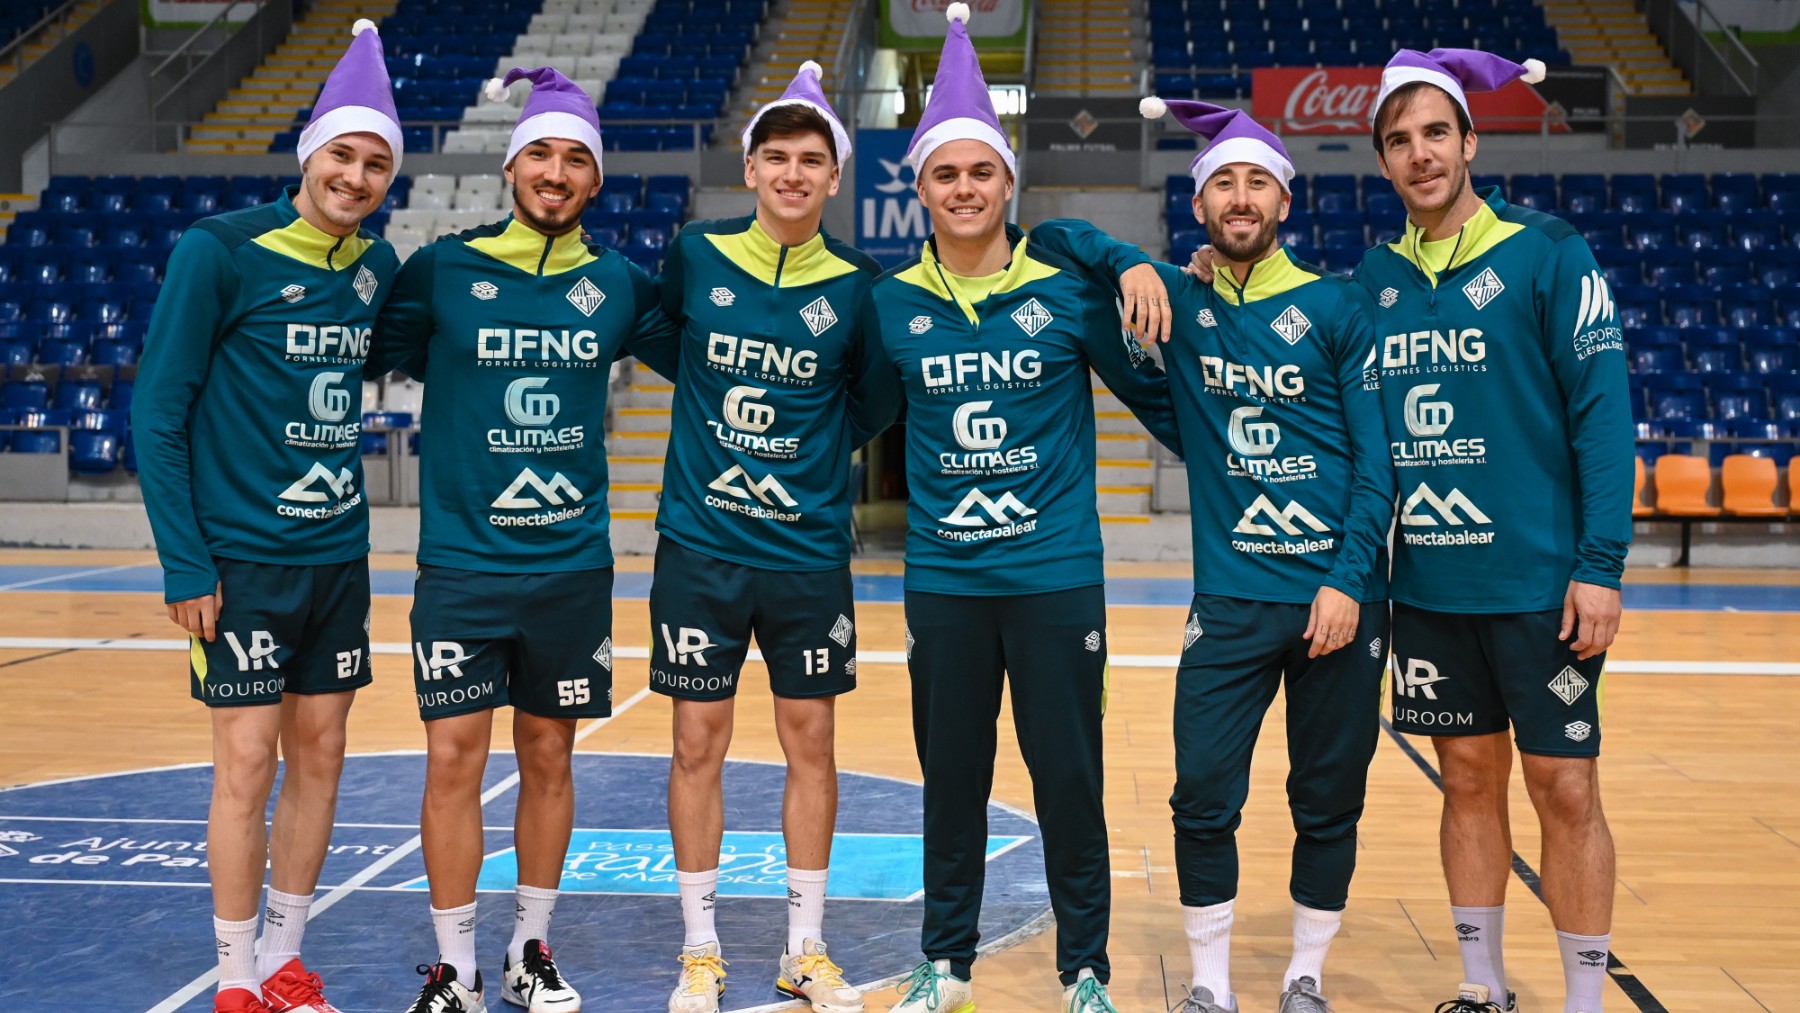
[131, 20, 401, 1013]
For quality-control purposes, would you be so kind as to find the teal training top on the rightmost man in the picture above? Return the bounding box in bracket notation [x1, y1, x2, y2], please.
[1355, 189, 1633, 614]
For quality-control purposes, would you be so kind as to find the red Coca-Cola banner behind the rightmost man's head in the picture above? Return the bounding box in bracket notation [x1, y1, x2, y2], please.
[1251, 67, 1606, 133]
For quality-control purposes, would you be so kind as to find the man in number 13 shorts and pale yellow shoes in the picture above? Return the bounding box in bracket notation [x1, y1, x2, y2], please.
[650, 59, 880, 1013]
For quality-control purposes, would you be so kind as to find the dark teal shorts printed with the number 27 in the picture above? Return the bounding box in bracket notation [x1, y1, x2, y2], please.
[187, 558, 371, 707]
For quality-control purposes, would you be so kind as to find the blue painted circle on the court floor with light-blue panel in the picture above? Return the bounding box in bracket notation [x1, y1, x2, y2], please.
[0, 752, 1049, 1013]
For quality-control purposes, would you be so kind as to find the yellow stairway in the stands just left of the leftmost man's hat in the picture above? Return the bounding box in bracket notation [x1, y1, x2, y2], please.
[185, 0, 396, 155]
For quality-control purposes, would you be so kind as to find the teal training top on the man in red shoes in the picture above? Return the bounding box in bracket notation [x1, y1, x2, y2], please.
[131, 187, 400, 601]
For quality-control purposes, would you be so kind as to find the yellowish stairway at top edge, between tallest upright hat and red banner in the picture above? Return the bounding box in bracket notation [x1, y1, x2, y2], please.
[1035, 0, 1147, 97]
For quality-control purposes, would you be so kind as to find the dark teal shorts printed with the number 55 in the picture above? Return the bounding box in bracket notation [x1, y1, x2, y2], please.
[412, 567, 612, 722]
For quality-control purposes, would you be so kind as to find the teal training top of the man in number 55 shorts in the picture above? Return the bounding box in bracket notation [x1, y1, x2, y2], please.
[374, 216, 675, 574]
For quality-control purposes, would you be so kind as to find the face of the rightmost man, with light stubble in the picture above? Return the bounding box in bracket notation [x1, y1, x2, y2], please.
[1375, 85, 1476, 220]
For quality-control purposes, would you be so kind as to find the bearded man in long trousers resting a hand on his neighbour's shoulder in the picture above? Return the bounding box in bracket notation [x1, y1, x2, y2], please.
[1031, 97, 1393, 1013]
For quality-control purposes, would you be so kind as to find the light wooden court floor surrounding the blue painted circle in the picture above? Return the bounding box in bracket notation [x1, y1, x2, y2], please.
[0, 551, 1800, 1013]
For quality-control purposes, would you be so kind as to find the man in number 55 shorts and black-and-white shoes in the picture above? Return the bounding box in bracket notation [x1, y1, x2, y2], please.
[374, 67, 675, 1013]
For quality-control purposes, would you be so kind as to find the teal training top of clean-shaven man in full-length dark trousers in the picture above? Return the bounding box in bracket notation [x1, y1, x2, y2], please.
[864, 225, 1181, 596]
